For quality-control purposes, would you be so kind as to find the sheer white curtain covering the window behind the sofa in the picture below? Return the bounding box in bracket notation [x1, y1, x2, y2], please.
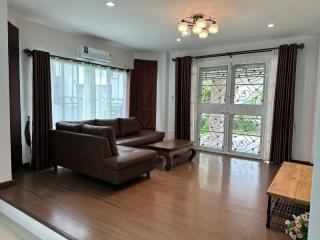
[51, 58, 127, 124]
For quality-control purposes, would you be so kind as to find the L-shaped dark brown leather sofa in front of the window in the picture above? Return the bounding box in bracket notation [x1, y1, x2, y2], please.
[49, 118, 164, 185]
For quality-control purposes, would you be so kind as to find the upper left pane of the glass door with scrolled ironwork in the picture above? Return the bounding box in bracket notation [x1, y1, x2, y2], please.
[199, 66, 228, 104]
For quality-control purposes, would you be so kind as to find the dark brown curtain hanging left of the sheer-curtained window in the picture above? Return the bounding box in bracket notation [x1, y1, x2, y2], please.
[31, 51, 52, 170]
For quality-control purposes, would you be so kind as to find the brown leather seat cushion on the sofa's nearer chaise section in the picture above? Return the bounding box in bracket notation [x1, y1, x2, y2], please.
[104, 146, 157, 170]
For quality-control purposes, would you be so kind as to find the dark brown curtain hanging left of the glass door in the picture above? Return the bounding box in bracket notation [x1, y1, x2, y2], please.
[175, 57, 192, 140]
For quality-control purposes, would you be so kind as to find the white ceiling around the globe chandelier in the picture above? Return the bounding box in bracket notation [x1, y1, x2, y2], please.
[8, 0, 320, 51]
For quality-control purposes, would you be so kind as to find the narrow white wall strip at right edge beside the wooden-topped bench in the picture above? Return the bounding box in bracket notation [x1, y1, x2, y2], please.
[309, 42, 320, 240]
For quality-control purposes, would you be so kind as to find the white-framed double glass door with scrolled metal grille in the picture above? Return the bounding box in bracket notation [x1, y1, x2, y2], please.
[197, 61, 268, 158]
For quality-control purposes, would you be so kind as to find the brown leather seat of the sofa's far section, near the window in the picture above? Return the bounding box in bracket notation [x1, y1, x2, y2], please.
[117, 129, 165, 147]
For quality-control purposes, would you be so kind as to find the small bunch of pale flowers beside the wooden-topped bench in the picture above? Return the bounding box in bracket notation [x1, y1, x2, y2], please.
[285, 213, 309, 240]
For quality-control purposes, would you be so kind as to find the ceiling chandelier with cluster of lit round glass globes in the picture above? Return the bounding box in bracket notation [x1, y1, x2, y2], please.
[178, 14, 219, 39]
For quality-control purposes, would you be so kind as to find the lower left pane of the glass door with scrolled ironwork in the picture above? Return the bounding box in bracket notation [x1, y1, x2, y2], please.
[199, 113, 225, 150]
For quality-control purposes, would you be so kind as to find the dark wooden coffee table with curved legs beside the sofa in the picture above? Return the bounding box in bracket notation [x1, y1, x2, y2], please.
[147, 139, 196, 171]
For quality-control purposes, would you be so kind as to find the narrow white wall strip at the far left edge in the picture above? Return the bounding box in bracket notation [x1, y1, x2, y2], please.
[0, 0, 12, 183]
